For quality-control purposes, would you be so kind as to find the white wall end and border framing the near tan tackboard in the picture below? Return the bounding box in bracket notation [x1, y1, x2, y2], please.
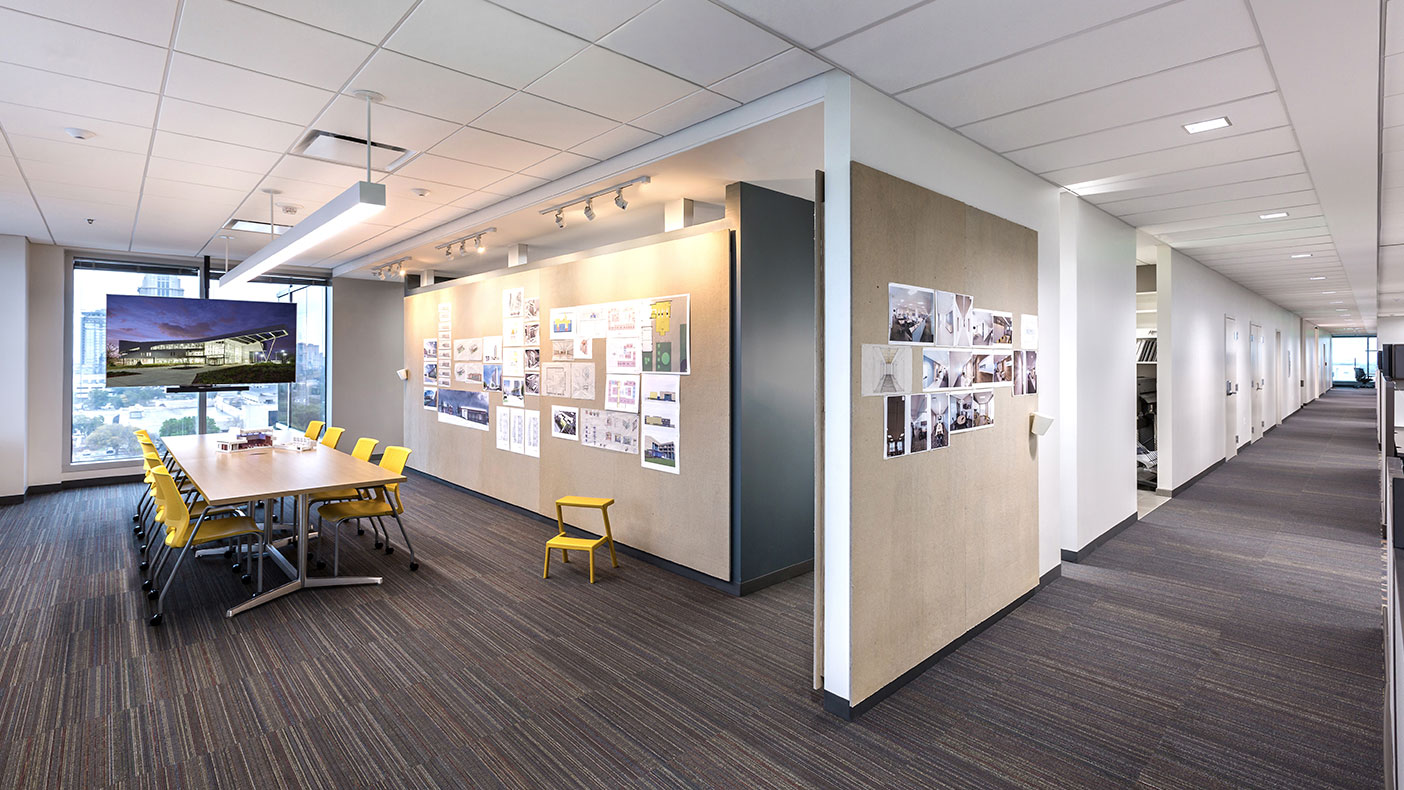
[823, 72, 1061, 699]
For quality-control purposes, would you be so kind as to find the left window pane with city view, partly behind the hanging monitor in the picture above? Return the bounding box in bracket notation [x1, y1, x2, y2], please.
[69, 261, 199, 464]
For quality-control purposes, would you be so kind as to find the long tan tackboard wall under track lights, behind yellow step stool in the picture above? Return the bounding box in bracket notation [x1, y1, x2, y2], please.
[404, 230, 731, 581]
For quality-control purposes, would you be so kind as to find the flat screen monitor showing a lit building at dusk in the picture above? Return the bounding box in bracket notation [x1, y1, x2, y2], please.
[107, 295, 298, 387]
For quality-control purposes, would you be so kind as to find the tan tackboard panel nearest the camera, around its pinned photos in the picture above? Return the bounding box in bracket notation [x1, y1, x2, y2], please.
[831, 163, 1039, 704]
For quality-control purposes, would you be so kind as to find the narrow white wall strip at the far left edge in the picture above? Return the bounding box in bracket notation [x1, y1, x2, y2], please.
[0, 236, 29, 498]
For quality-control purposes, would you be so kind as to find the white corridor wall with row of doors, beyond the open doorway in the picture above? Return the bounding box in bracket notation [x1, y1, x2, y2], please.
[1157, 247, 1303, 490]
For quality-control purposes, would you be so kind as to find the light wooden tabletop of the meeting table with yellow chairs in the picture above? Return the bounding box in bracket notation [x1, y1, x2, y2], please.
[163, 434, 404, 505]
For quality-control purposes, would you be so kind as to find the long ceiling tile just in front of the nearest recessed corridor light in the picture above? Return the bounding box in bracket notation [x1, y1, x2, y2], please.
[959, 49, 1280, 152]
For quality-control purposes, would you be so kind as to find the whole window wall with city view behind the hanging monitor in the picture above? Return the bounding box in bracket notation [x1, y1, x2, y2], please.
[69, 261, 330, 466]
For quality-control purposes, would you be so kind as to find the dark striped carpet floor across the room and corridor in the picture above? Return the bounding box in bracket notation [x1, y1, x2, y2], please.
[0, 391, 1383, 790]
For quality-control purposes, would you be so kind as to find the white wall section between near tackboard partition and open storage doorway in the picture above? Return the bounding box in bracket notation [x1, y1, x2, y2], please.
[1039, 192, 1136, 551]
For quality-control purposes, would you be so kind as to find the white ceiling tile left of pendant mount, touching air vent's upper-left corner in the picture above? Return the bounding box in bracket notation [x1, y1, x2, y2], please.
[166, 52, 333, 125]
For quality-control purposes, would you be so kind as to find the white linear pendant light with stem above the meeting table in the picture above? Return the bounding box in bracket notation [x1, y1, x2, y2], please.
[219, 91, 385, 288]
